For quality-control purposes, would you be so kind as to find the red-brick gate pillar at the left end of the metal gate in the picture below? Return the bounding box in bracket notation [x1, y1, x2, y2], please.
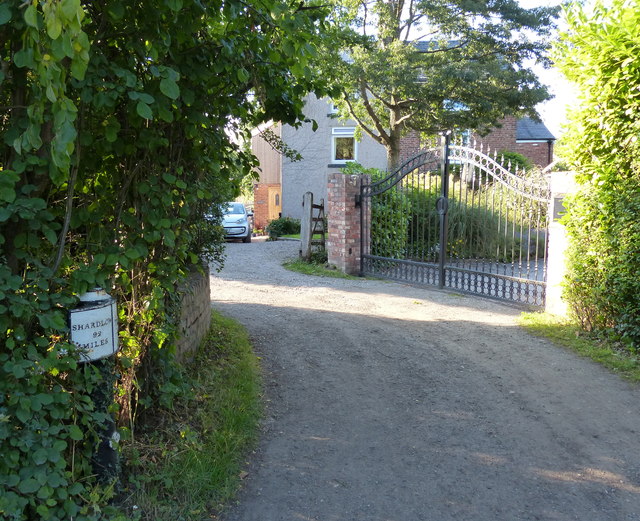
[327, 173, 366, 275]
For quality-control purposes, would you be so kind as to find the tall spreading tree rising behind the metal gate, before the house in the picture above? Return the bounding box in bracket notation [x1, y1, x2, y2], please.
[323, 0, 558, 168]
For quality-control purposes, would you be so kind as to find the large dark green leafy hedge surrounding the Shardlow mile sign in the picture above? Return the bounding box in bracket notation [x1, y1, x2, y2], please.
[0, 0, 332, 521]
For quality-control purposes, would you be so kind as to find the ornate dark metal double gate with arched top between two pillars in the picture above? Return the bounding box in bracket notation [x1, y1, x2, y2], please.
[360, 136, 550, 306]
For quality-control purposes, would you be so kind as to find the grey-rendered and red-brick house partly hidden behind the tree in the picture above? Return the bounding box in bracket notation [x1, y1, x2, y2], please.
[251, 95, 555, 228]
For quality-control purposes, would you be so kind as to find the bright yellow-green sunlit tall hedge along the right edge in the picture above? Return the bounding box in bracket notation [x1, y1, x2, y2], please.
[557, 0, 640, 349]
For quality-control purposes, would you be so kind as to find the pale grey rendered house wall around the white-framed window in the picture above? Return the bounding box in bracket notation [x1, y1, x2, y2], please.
[282, 95, 387, 219]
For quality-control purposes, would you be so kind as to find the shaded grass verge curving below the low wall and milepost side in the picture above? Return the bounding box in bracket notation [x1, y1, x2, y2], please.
[122, 311, 262, 521]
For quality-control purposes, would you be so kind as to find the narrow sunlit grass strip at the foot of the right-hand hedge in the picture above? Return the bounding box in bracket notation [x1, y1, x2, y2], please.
[519, 313, 640, 382]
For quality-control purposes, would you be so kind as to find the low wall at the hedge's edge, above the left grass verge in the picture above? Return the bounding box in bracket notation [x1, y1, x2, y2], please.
[176, 268, 211, 360]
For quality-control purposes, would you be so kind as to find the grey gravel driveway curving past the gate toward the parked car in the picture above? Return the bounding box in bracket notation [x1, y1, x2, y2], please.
[211, 241, 640, 521]
